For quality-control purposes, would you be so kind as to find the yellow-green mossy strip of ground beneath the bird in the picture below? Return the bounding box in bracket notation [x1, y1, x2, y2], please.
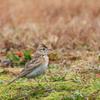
[0, 66, 100, 100]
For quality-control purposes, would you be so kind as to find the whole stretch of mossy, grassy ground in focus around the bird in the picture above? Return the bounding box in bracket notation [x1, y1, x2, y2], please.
[0, 50, 100, 100]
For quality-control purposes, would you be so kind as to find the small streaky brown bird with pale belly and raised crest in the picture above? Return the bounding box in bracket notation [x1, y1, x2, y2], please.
[8, 43, 51, 85]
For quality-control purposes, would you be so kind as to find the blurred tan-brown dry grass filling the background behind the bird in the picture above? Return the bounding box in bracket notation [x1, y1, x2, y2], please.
[0, 0, 100, 50]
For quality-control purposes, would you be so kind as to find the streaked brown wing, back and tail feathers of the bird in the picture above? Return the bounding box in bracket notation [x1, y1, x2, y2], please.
[9, 44, 47, 84]
